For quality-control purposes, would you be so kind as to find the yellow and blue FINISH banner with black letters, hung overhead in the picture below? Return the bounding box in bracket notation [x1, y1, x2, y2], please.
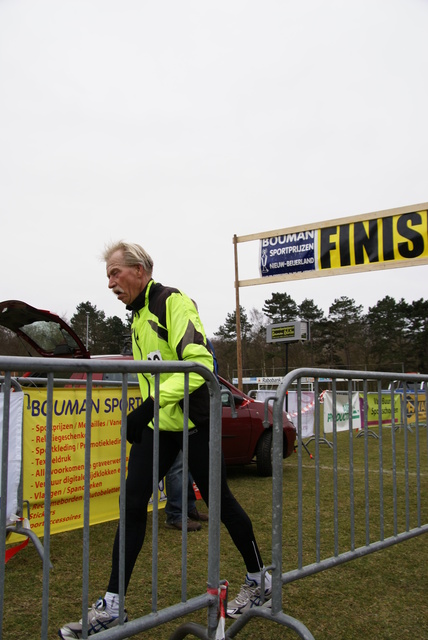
[259, 207, 428, 278]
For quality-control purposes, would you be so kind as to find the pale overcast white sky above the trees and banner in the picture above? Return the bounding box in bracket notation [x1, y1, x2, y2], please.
[0, 0, 428, 336]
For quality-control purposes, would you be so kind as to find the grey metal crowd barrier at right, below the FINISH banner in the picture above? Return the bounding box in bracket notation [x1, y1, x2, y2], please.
[226, 369, 428, 640]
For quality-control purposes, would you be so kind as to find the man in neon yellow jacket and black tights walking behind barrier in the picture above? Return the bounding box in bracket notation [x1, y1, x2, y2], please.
[58, 242, 271, 640]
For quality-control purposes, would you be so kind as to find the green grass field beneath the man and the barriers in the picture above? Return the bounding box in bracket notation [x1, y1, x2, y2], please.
[3, 429, 428, 640]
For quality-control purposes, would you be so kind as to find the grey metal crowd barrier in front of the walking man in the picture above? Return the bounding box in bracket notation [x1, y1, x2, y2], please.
[0, 356, 221, 640]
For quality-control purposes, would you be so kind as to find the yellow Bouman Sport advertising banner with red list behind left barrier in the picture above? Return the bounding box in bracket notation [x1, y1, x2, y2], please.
[17, 387, 165, 536]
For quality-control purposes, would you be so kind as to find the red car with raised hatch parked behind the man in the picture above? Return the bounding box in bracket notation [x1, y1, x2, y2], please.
[0, 300, 296, 476]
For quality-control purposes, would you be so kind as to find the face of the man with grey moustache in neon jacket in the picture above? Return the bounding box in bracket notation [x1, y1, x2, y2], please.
[106, 251, 149, 304]
